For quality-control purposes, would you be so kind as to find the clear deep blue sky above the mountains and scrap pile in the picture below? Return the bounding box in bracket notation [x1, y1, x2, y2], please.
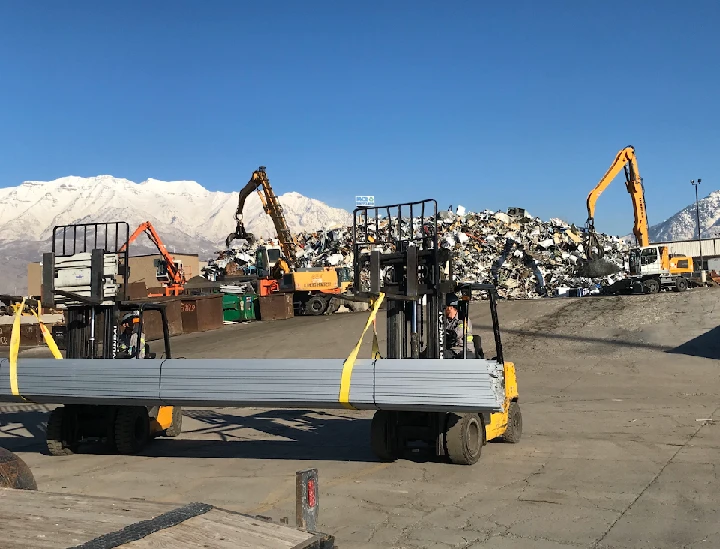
[0, 0, 720, 234]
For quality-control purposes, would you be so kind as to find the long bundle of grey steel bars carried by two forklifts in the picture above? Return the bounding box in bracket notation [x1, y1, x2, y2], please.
[0, 358, 504, 412]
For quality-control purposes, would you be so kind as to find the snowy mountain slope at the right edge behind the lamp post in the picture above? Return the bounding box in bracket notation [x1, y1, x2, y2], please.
[650, 191, 720, 242]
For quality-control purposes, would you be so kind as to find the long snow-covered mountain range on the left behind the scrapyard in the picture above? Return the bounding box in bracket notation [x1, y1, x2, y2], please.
[0, 175, 352, 293]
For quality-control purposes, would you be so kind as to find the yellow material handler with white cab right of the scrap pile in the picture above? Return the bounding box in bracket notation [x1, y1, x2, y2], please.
[584, 145, 694, 293]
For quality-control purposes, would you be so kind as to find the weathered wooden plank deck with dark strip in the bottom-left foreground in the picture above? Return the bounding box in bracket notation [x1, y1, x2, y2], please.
[0, 488, 334, 549]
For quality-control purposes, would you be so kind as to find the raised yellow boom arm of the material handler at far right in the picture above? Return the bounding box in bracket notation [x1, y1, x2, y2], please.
[586, 146, 650, 259]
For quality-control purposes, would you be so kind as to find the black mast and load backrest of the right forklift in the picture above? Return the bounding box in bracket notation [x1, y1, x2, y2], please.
[353, 199, 452, 359]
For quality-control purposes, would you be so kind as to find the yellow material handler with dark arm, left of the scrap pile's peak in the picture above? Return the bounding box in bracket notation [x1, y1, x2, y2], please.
[225, 166, 351, 315]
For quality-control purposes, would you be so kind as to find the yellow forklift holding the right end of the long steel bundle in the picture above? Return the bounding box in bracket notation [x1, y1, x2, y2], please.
[353, 200, 522, 465]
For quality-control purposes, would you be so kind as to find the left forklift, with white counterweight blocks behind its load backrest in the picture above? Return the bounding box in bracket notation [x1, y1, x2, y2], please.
[42, 222, 182, 456]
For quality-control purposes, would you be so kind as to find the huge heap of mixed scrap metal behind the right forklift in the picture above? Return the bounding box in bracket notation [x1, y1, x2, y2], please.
[206, 206, 629, 299]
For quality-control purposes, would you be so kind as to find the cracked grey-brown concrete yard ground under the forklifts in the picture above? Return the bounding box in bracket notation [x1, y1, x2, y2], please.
[0, 289, 720, 549]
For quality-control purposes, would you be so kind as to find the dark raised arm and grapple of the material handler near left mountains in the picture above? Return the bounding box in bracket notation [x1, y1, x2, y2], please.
[225, 166, 297, 269]
